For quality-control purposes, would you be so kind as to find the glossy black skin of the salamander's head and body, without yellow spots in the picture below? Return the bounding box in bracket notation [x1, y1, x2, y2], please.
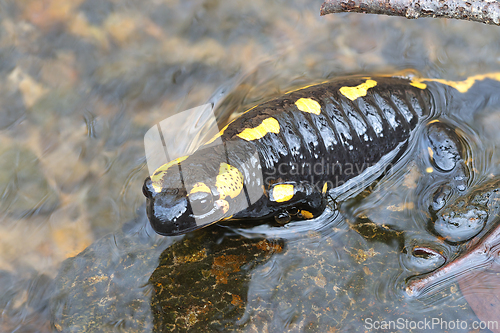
[143, 77, 433, 235]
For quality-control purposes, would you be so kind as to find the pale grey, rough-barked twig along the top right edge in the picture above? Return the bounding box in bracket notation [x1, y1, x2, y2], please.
[320, 0, 500, 25]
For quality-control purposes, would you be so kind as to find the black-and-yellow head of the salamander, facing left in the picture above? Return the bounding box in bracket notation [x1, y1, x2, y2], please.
[143, 154, 246, 236]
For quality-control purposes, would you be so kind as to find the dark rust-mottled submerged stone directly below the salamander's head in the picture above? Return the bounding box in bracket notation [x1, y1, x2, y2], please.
[150, 230, 283, 332]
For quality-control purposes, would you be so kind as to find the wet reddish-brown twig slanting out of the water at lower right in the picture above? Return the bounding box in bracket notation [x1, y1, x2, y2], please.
[406, 225, 500, 297]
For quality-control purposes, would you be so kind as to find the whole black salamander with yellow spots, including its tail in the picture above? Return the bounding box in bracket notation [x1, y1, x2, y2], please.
[143, 73, 500, 235]
